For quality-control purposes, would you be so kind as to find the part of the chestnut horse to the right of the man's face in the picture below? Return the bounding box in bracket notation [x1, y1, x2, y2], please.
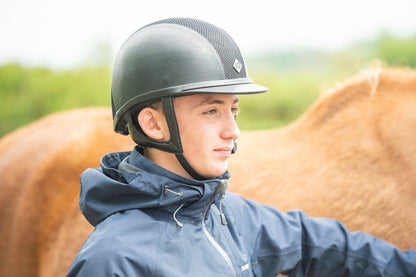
[231, 67, 416, 249]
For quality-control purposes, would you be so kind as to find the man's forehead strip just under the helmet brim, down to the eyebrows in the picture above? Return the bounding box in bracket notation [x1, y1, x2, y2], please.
[175, 93, 239, 108]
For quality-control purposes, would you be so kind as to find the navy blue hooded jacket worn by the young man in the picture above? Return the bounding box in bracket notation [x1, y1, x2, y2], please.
[67, 146, 416, 277]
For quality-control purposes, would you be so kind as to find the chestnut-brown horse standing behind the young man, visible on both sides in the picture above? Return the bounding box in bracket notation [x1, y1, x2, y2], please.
[0, 67, 416, 277]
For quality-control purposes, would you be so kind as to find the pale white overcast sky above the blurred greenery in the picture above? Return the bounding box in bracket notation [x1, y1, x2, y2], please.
[0, 0, 416, 68]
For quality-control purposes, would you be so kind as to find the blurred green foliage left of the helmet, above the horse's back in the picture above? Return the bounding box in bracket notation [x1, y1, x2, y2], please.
[0, 64, 111, 136]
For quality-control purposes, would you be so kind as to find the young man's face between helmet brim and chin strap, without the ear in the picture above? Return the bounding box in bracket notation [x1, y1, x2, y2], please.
[174, 94, 240, 178]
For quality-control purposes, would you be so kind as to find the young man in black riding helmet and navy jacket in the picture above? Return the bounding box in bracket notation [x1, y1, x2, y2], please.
[67, 18, 416, 277]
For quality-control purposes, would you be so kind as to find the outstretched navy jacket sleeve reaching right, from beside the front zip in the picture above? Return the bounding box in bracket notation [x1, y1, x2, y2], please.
[227, 194, 416, 277]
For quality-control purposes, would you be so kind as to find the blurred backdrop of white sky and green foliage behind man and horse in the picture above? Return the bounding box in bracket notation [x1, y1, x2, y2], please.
[0, 0, 416, 137]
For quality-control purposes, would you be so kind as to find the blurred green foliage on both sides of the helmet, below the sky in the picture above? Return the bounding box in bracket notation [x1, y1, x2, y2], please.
[0, 33, 416, 136]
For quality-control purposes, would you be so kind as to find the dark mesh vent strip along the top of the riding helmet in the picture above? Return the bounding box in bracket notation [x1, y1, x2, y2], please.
[144, 18, 247, 79]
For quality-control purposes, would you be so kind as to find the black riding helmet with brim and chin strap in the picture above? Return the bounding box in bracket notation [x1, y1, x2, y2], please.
[111, 18, 267, 179]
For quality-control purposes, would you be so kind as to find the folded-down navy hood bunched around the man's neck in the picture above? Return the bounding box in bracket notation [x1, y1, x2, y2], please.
[79, 148, 230, 226]
